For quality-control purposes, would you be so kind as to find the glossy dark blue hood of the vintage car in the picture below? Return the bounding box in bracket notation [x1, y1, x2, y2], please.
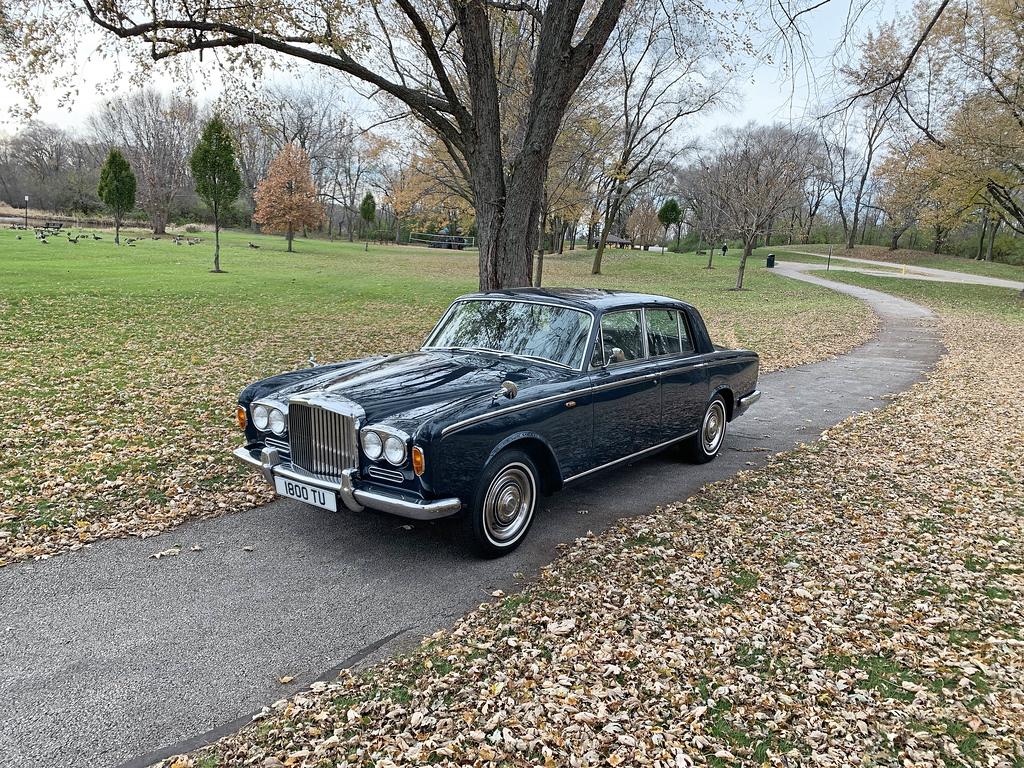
[288, 351, 575, 426]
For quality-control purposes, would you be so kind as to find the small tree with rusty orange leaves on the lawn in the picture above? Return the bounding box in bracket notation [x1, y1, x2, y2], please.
[253, 143, 324, 253]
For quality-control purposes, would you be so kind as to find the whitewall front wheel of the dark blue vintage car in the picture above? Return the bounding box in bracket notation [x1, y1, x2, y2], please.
[456, 451, 539, 557]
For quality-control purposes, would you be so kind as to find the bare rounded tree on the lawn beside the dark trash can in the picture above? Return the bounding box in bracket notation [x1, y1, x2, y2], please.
[705, 123, 809, 291]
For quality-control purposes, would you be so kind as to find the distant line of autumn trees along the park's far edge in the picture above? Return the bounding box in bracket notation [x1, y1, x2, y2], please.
[0, 0, 1024, 276]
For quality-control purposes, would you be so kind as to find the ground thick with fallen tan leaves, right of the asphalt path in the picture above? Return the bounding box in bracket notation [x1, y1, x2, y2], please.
[172, 303, 1024, 768]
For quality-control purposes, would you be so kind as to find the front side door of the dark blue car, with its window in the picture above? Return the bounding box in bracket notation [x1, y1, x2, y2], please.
[591, 309, 662, 467]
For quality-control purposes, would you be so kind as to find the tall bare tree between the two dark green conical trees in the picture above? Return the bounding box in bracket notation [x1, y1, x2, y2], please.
[89, 88, 201, 234]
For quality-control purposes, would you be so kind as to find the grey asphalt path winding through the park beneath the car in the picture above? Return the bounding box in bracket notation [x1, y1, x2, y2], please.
[0, 264, 942, 768]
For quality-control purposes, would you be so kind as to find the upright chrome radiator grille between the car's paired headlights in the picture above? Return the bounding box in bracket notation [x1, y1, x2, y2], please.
[288, 402, 358, 475]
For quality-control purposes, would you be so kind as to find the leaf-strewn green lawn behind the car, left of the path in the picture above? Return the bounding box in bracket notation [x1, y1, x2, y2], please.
[0, 229, 870, 564]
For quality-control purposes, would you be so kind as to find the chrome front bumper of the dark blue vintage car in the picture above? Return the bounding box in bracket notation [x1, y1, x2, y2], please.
[232, 445, 462, 520]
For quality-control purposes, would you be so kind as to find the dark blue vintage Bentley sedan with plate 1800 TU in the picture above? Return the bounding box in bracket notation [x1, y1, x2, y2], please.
[234, 288, 761, 556]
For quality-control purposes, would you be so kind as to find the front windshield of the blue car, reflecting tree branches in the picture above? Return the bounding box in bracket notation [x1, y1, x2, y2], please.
[424, 300, 591, 369]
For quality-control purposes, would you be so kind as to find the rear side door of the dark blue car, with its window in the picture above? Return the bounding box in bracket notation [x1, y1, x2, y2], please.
[644, 307, 709, 442]
